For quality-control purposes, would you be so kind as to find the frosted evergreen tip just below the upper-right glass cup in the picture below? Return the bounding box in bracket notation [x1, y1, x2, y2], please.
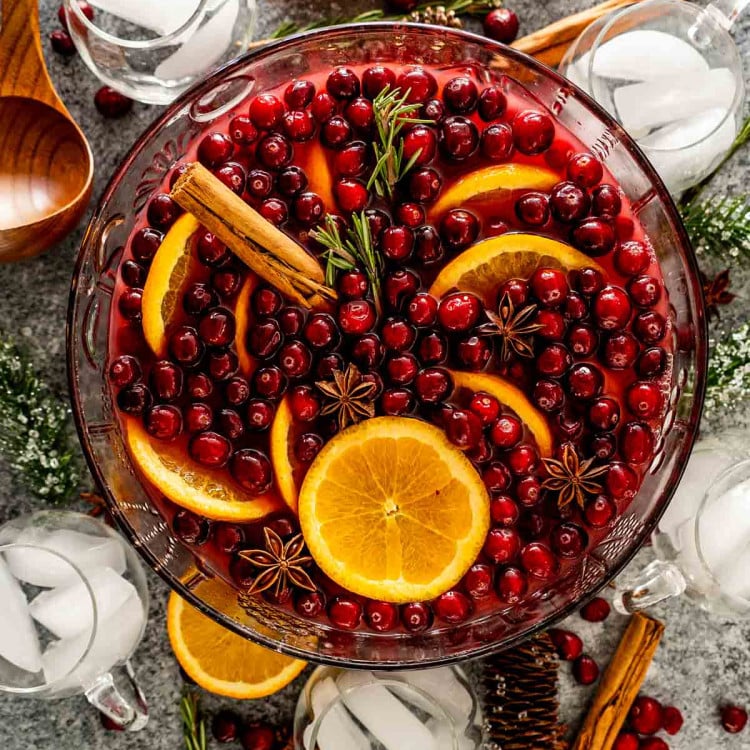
[681, 195, 750, 260]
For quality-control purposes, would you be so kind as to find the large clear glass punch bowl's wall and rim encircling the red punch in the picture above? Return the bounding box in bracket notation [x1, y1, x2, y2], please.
[67, 24, 707, 668]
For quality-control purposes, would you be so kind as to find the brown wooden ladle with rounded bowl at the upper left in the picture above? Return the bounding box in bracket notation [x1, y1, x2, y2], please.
[0, 0, 94, 261]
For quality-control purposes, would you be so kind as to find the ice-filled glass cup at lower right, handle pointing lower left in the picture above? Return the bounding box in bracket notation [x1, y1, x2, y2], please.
[614, 452, 750, 619]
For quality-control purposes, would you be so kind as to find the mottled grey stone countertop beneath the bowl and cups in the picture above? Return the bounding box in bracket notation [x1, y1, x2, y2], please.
[0, 0, 750, 750]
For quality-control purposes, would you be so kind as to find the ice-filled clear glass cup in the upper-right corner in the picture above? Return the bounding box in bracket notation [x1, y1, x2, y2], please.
[559, 0, 747, 195]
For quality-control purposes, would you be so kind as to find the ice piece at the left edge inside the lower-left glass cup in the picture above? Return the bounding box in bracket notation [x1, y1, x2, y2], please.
[0, 557, 42, 672]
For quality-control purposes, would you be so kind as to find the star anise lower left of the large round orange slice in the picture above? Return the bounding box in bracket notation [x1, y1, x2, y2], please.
[239, 527, 315, 598]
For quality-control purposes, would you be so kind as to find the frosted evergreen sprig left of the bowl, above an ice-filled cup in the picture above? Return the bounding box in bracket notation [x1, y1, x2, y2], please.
[0, 337, 80, 504]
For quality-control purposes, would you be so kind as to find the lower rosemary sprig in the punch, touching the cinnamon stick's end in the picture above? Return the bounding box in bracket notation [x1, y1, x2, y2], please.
[310, 211, 384, 315]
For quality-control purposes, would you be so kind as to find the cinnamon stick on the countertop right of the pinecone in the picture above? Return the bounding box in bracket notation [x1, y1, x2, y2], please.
[571, 613, 664, 750]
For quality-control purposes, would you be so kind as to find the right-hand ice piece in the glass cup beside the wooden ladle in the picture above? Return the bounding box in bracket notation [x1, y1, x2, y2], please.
[154, 0, 240, 81]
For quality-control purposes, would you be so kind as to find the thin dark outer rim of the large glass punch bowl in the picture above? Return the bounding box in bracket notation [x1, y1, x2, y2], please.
[66, 22, 708, 669]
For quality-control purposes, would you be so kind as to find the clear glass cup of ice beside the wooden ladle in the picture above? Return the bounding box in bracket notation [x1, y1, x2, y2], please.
[64, 0, 257, 104]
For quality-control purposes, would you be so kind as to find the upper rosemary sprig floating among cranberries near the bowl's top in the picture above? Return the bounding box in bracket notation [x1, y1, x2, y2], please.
[367, 86, 433, 198]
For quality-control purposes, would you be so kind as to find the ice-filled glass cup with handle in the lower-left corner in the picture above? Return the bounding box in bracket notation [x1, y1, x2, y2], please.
[0, 511, 148, 731]
